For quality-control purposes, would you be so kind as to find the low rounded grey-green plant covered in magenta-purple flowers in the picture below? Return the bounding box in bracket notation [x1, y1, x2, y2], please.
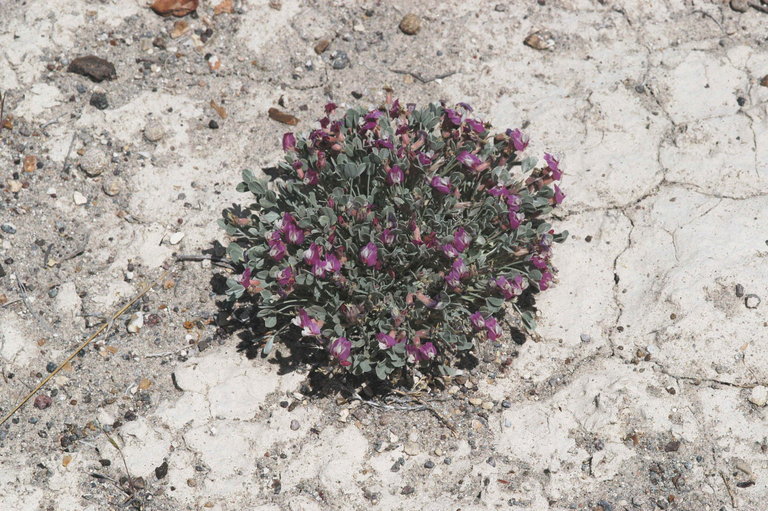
[221, 100, 567, 380]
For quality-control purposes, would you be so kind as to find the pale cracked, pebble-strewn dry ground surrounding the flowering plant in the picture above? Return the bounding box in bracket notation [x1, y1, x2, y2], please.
[0, 0, 768, 511]
